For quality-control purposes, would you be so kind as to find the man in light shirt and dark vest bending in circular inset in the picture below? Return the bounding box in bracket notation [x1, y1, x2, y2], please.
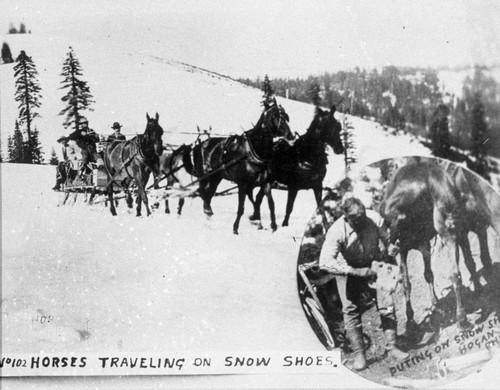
[319, 198, 408, 371]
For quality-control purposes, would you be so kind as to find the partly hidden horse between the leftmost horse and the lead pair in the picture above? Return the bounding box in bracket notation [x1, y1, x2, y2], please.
[159, 144, 194, 215]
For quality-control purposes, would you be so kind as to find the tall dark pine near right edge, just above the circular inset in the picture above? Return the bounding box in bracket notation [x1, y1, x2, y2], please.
[470, 92, 489, 178]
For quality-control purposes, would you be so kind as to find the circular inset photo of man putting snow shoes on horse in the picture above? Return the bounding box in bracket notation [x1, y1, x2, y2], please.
[297, 156, 500, 388]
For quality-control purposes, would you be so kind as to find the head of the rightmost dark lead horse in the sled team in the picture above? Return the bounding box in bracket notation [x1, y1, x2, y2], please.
[306, 106, 344, 154]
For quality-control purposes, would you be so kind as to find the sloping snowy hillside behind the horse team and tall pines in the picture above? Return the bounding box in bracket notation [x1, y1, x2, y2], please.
[0, 34, 429, 188]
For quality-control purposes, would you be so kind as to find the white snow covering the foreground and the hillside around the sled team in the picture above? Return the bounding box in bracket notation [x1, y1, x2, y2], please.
[0, 28, 500, 388]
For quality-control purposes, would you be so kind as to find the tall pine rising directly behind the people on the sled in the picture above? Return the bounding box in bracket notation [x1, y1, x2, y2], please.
[59, 47, 95, 130]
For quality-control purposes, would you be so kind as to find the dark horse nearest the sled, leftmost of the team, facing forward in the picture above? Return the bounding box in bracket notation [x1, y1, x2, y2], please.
[104, 113, 163, 217]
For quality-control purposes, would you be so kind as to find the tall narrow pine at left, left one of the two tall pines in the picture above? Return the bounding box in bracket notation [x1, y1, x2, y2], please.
[14, 50, 42, 163]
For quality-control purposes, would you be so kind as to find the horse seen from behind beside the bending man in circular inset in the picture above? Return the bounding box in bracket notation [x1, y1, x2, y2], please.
[379, 161, 477, 329]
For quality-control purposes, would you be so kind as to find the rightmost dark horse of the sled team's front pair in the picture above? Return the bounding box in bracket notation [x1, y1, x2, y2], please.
[250, 106, 344, 226]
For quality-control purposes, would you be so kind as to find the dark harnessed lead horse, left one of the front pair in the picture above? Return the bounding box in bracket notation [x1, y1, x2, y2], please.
[184, 101, 293, 234]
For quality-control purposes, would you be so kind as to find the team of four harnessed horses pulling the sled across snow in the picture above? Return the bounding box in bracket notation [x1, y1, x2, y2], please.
[104, 99, 344, 234]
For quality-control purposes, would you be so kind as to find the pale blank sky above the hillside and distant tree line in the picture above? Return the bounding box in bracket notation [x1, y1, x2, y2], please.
[0, 0, 500, 78]
